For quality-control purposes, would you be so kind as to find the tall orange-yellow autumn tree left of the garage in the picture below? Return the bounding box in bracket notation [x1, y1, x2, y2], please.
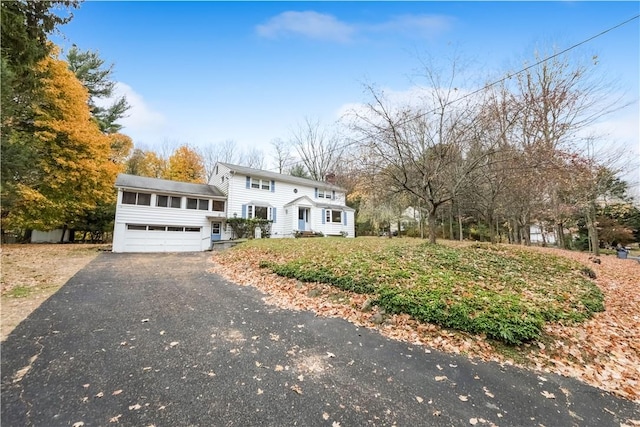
[7, 48, 119, 230]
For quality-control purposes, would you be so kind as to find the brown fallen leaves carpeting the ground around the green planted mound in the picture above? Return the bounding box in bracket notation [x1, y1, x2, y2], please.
[212, 239, 640, 402]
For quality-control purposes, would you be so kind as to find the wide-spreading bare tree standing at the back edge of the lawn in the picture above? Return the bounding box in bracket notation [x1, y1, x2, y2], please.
[352, 55, 490, 243]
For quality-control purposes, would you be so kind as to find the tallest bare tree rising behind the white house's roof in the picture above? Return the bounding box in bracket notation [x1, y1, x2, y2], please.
[291, 118, 344, 181]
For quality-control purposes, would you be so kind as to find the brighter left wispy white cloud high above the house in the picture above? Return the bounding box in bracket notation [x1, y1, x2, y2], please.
[256, 11, 354, 42]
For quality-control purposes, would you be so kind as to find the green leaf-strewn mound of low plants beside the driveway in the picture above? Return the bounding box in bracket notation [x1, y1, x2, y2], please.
[234, 238, 604, 344]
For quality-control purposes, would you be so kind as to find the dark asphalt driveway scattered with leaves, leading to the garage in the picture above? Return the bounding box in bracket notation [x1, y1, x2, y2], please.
[1, 253, 640, 427]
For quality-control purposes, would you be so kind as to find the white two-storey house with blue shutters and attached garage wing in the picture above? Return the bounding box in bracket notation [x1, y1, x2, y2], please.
[113, 163, 355, 252]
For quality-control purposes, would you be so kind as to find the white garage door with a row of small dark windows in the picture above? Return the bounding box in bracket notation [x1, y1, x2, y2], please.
[124, 224, 203, 252]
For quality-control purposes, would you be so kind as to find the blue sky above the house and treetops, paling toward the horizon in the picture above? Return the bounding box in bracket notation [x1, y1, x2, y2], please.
[54, 1, 640, 183]
